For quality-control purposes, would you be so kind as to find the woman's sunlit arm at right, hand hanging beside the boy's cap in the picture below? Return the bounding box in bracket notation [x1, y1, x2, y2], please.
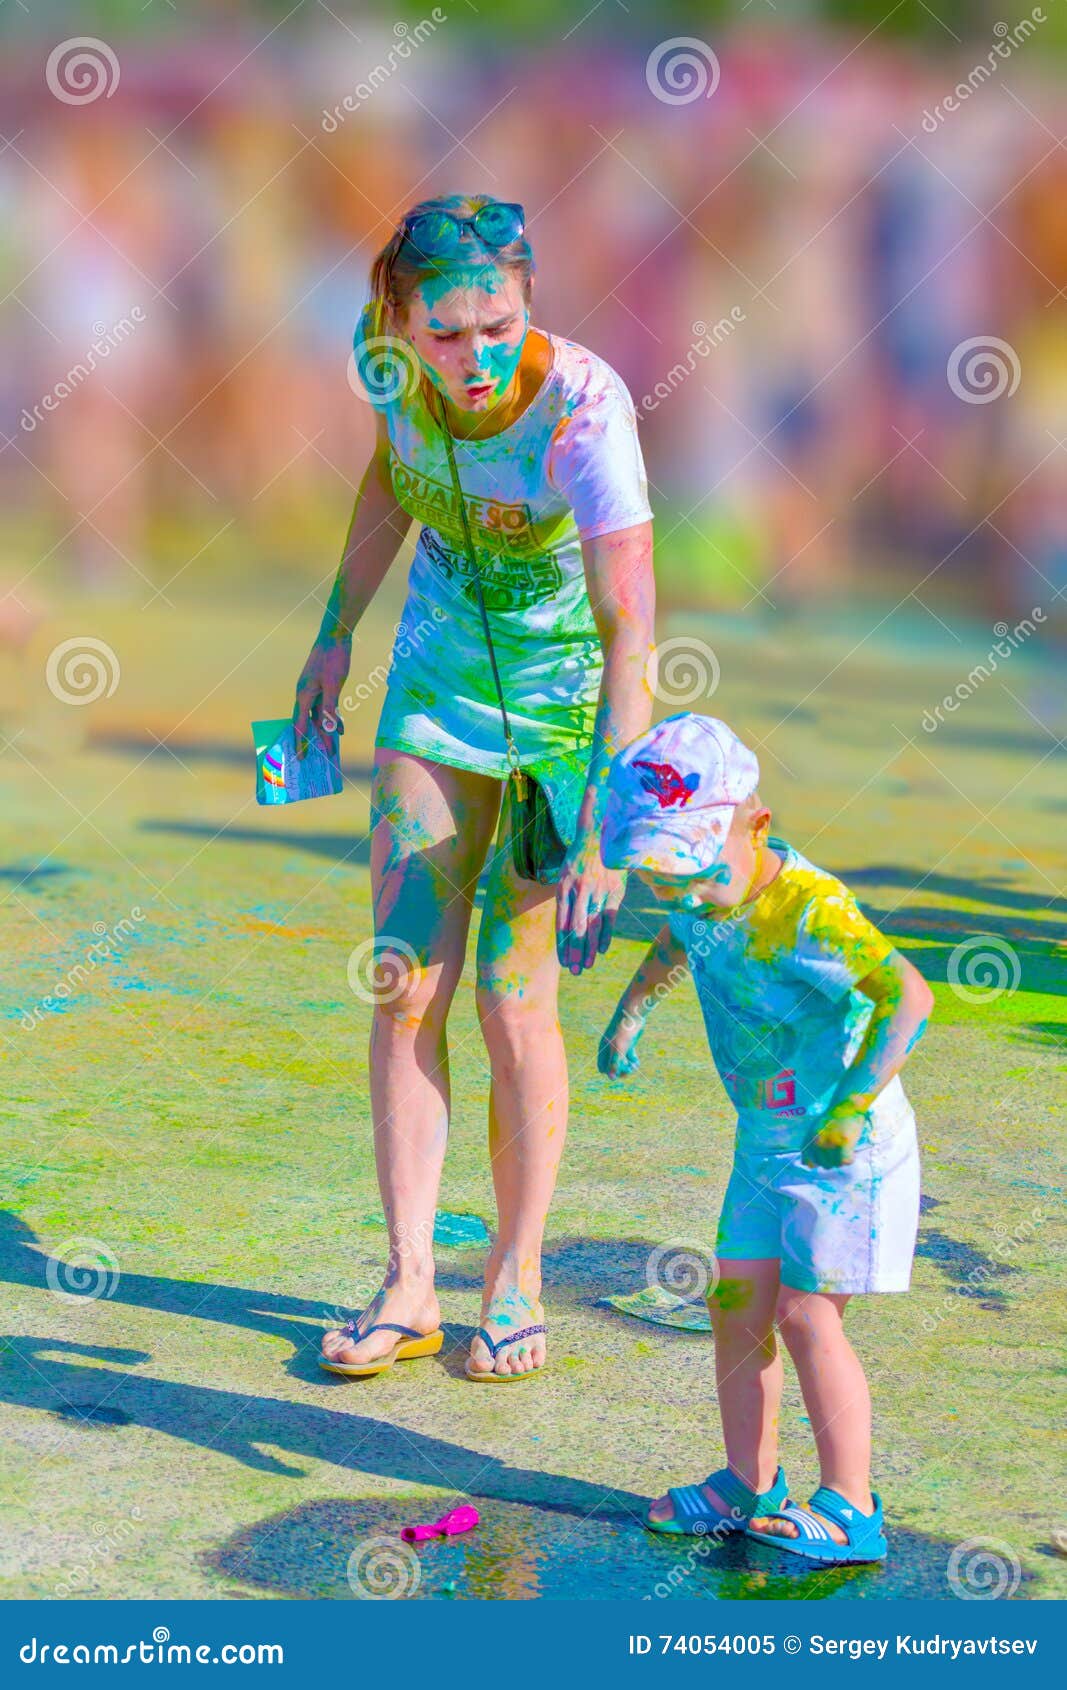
[556, 522, 656, 973]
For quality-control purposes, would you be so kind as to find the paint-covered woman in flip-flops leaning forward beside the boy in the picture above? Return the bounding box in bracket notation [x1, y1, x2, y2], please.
[294, 194, 654, 1382]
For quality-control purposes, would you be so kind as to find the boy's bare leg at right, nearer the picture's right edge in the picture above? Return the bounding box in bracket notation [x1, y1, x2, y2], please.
[752, 1284, 874, 1543]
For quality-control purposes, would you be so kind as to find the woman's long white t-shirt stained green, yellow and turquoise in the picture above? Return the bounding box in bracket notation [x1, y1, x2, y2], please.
[355, 313, 653, 776]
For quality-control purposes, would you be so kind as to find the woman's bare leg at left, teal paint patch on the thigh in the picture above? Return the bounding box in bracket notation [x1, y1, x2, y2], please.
[323, 749, 501, 1362]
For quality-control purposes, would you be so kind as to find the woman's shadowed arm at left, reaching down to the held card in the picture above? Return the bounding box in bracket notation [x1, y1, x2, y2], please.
[293, 412, 411, 757]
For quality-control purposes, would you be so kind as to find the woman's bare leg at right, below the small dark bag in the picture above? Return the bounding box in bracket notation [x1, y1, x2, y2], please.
[470, 811, 568, 1372]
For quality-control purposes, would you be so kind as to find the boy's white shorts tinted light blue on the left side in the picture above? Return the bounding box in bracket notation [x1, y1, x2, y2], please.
[715, 1078, 920, 1296]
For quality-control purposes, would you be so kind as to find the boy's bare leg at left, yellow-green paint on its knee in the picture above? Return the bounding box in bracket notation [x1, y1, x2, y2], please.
[649, 1261, 781, 1521]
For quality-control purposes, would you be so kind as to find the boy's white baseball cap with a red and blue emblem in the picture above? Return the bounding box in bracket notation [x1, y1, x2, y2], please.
[600, 710, 759, 874]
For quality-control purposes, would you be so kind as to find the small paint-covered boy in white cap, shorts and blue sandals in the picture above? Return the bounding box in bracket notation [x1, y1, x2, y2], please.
[599, 711, 933, 1562]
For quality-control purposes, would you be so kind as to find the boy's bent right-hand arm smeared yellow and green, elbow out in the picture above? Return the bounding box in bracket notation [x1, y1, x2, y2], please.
[805, 950, 933, 1168]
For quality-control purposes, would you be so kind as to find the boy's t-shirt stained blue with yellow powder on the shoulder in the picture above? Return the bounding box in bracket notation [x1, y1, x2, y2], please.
[670, 838, 900, 1149]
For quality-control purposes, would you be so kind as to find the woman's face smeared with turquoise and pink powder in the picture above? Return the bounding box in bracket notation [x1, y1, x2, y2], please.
[402, 264, 529, 412]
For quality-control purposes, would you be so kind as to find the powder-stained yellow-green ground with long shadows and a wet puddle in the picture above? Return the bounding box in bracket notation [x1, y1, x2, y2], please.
[0, 586, 1067, 1600]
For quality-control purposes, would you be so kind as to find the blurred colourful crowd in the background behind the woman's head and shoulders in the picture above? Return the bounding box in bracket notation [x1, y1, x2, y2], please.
[0, 0, 1067, 629]
